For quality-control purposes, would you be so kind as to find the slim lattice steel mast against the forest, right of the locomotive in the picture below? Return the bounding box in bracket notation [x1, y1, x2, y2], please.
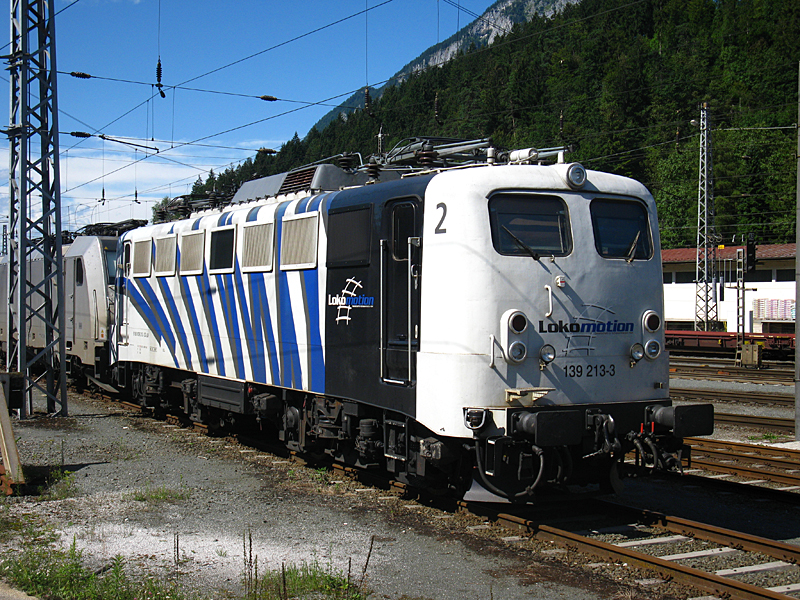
[694, 103, 718, 331]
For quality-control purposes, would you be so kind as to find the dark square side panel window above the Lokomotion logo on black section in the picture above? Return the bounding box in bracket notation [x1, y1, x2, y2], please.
[328, 206, 372, 267]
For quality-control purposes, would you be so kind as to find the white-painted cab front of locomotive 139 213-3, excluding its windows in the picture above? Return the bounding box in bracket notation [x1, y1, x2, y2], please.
[417, 165, 669, 437]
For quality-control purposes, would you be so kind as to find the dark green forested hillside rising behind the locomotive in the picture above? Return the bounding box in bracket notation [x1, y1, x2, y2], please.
[193, 0, 800, 247]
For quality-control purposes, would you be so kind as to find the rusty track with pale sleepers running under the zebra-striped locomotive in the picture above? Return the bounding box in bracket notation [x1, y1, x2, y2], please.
[86, 390, 800, 600]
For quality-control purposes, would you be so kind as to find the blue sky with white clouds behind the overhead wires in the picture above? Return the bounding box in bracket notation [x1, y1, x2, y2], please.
[0, 0, 492, 230]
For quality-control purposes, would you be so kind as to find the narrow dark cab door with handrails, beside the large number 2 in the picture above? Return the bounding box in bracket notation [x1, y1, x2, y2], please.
[381, 199, 422, 385]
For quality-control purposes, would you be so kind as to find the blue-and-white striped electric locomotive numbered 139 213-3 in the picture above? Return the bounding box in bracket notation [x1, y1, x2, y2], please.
[106, 139, 713, 501]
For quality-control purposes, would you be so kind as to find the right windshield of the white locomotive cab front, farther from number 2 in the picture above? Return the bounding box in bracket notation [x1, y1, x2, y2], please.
[591, 199, 653, 260]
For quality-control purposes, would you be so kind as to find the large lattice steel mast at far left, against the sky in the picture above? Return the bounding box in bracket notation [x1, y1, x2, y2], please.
[6, 0, 67, 417]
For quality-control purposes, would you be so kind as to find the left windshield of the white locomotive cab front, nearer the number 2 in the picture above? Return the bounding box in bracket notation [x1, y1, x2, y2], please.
[489, 194, 572, 256]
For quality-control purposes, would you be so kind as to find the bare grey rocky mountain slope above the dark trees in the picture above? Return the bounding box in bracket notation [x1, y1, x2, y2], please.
[314, 0, 580, 131]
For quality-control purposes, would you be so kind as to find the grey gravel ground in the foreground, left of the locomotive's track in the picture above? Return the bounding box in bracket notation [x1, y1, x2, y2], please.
[0, 398, 648, 600]
